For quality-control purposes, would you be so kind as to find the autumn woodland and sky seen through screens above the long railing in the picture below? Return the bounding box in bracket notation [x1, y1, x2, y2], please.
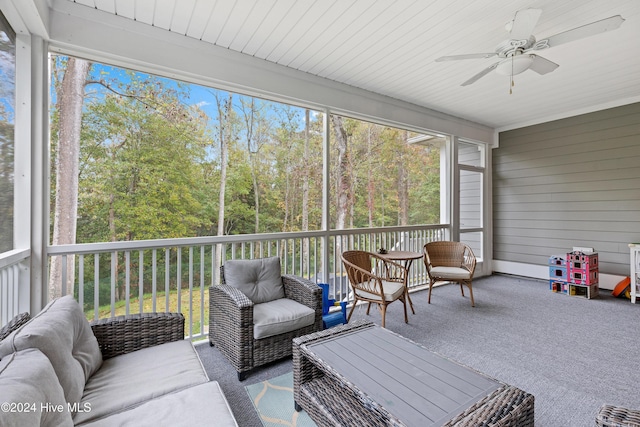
[51, 58, 440, 247]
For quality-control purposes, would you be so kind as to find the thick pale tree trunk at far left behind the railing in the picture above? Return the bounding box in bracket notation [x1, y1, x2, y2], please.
[49, 58, 91, 298]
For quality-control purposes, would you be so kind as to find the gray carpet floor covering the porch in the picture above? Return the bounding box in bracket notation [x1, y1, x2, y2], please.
[196, 275, 640, 427]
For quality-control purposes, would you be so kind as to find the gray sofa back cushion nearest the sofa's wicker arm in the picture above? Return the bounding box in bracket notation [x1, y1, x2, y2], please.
[0, 295, 102, 408]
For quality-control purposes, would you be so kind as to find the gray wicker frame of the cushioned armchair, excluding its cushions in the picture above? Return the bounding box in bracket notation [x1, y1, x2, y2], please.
[209, 261, 322, 381]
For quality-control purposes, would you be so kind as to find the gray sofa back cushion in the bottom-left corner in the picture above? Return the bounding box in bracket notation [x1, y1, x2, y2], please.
[0, 349, 73, 427]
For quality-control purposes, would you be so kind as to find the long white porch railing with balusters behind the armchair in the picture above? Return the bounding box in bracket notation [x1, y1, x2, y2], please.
[48, 225, 449, 339]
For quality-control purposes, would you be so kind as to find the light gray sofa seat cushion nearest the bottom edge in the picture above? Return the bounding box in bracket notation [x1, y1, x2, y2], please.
[82, 381, 238, 427]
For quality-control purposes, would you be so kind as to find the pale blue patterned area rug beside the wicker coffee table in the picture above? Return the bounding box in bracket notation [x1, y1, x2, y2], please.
[245, 372, 316, 427]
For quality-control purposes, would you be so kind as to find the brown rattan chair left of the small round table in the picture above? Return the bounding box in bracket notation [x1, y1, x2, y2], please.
[342, 251, 409, 328]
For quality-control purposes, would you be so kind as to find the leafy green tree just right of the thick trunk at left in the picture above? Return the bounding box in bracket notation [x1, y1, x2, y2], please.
[81, 74, 206, 241]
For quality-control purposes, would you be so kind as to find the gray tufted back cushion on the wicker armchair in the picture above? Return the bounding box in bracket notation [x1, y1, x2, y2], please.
[224, 257, 284, 304]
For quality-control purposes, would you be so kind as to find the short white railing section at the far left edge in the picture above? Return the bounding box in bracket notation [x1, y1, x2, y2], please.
[0, 249, 29, 326]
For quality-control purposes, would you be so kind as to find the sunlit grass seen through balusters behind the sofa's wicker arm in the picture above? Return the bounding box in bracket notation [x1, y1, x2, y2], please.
[85, 287, 209, 334]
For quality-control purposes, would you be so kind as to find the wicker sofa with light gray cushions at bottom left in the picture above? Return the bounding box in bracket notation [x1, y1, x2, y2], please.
[0, 296, 237, 427]
